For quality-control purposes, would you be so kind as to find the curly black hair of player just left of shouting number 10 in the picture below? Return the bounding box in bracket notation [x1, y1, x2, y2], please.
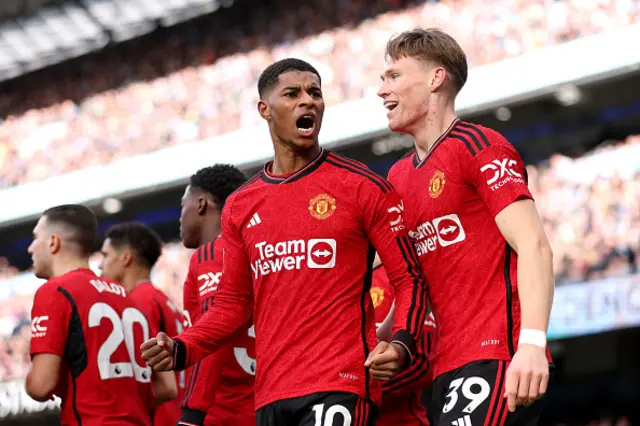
[189, 164, 247, 210]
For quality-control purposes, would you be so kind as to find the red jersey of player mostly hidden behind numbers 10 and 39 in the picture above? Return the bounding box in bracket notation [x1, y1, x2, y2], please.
[371, 265, 435, 426]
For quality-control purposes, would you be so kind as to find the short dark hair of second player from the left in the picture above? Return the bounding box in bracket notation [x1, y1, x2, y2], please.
[105, 222, 162, 268]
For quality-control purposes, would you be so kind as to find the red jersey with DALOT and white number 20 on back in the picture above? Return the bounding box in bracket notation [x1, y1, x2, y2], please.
[31, 269, 151, 426]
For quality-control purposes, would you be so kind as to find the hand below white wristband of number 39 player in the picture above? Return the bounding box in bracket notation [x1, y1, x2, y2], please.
[504, 344, 549, 413]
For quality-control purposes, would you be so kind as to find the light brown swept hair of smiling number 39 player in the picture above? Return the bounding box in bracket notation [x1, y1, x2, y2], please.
[385, 28, 469, 93]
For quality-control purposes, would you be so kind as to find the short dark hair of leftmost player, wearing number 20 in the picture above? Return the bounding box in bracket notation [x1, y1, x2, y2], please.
[42, 204, 98, 255]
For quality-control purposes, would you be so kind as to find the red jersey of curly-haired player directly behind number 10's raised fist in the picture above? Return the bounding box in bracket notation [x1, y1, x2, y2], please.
[182, 237, 256, 426]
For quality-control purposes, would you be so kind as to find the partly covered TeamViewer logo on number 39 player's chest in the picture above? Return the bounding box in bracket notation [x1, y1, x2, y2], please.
[409, 214, 467, 256]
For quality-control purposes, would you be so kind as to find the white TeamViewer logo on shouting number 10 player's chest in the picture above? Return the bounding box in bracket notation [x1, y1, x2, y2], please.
[251, 238, 337, 279]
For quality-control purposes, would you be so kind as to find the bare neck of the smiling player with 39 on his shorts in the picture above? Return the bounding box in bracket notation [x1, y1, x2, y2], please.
[408, 94, 456, 158]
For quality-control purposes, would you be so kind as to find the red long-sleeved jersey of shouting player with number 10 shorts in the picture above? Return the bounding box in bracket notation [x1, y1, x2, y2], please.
[175, 150, 427, 409]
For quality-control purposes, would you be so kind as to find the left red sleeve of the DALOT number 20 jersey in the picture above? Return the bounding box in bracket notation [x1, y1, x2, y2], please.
[31, 283, 71, 357]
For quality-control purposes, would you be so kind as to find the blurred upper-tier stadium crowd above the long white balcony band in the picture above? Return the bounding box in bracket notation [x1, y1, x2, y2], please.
[0, 0, 640, 188]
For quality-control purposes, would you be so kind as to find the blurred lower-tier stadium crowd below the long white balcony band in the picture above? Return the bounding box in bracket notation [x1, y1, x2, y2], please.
[0, 132, 640, 381]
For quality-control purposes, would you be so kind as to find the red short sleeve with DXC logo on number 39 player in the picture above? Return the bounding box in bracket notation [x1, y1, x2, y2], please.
[462, 129, 533, 216]
